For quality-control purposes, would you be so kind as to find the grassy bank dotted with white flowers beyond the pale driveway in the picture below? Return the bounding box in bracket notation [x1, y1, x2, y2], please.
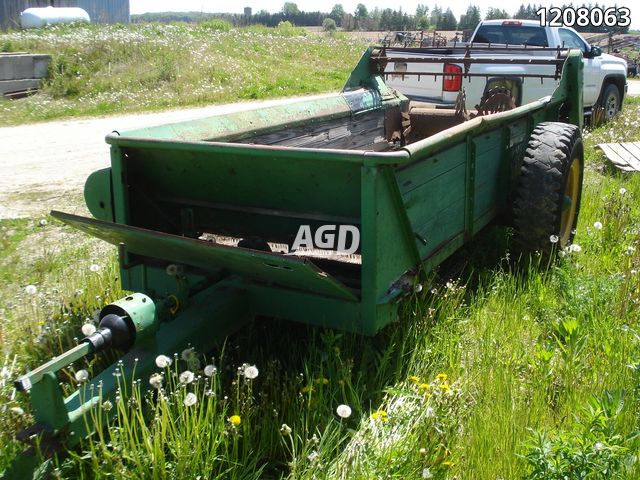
[0, 21, 366, 125]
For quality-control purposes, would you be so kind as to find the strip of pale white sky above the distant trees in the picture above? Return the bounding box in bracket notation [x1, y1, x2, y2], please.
[130, 0, 640, 29]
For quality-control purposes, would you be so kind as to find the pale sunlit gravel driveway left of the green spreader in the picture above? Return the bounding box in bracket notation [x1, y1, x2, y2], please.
[0, 95, 322, 219]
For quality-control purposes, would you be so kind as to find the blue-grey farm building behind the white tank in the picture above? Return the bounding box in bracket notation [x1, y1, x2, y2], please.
[0, 0, 129, 29]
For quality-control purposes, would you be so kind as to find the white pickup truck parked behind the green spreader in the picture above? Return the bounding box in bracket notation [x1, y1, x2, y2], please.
[385, 19, 627, 118]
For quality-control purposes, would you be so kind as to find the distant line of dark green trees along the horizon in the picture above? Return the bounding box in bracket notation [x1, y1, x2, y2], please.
[131, 2, 629, 33]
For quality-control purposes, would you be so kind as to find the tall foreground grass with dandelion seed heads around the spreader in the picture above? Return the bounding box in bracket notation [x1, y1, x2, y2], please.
[0, 29, 640, 480]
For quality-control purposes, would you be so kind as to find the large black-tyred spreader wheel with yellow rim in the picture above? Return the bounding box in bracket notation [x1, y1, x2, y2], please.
[513, 122, 584, 255]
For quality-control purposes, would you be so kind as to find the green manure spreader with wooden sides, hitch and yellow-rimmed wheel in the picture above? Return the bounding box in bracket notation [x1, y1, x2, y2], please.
[15, 48, 583, 464]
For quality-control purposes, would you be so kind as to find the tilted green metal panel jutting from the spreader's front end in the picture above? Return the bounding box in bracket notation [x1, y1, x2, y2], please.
[51, 212, 356, 300]
